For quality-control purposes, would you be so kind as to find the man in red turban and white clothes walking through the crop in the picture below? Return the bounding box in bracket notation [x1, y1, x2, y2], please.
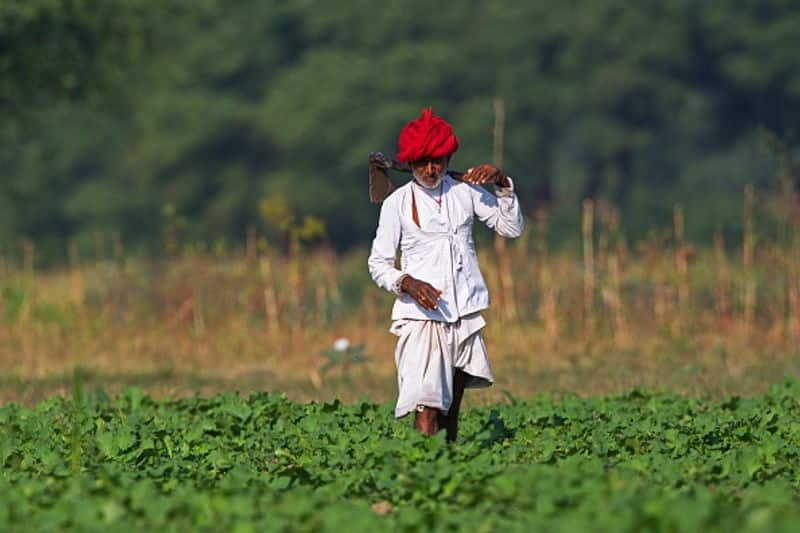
[368, 108, 523, 442]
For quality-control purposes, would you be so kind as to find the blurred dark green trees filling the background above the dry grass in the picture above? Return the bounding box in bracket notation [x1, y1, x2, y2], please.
[0, 0, 800, 260]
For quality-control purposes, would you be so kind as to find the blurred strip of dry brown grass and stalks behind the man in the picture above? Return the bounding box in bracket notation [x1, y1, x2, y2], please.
[0, 190, 800, 403]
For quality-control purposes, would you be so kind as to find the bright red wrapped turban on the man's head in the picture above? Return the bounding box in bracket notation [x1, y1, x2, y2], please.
[397, 107, 458, 163]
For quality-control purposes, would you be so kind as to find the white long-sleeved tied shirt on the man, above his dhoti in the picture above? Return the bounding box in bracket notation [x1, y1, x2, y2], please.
[367, 175, 523, 322]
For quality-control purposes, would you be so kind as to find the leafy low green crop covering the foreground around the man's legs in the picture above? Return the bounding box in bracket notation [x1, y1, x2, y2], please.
[0, 379, 800, 531]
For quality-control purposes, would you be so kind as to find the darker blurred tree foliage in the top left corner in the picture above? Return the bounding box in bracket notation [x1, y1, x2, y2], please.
[0, 0, 163, 116]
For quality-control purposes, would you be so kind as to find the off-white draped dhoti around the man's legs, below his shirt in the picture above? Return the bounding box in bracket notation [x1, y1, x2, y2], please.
[390, 313, 494, 418]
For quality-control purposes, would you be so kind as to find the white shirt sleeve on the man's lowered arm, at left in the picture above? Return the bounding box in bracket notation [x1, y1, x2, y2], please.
[367, 198, 406, 294]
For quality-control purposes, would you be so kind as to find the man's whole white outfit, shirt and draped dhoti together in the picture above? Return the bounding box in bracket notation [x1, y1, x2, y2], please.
[368, 176, 523, 417]
